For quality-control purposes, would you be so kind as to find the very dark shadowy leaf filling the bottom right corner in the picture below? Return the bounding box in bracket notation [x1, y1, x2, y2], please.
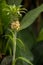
[32, 41, 43, 65]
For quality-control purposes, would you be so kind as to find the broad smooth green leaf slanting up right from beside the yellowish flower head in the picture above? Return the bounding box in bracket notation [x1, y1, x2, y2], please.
[20, 4, 43, 30]
